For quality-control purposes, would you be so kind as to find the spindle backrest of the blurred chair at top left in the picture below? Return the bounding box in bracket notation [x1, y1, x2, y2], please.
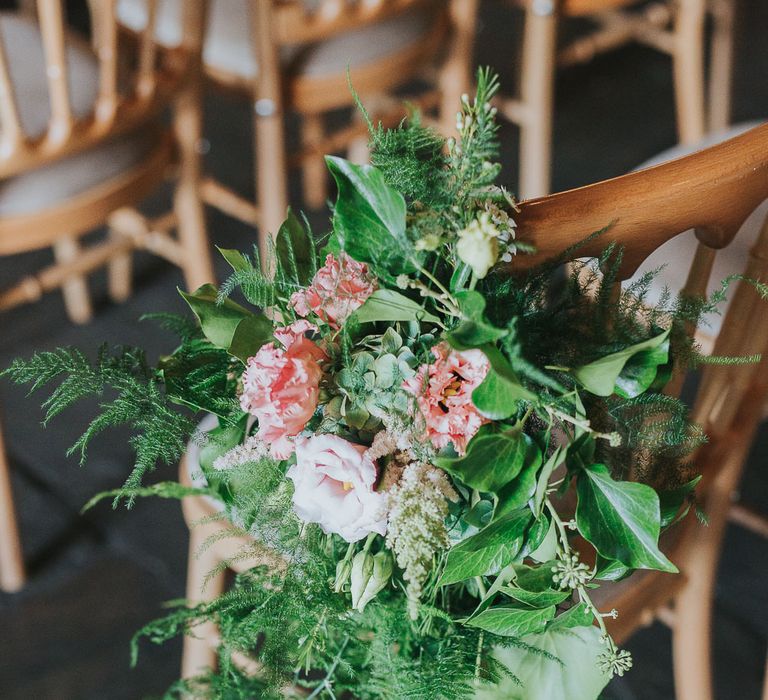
[0, 0, 204, 178]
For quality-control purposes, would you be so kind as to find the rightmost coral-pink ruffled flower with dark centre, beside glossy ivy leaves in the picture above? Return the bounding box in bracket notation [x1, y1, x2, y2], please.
[403, 343, 488, 455]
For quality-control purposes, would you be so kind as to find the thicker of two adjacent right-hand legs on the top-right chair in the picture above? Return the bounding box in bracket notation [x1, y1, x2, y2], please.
[672, 0, 706, 143]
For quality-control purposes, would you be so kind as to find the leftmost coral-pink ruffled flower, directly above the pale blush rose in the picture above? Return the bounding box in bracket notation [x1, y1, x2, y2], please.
[240, 321, 326, 459]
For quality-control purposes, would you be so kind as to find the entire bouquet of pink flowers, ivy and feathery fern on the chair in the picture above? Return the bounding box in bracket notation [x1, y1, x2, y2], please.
[7, 71, 732, 700]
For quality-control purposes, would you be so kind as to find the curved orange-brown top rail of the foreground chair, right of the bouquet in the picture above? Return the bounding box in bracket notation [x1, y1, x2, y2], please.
[508, 124, 768, 279]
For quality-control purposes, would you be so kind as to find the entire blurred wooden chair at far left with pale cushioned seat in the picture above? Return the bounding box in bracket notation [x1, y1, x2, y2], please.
[0, 0, 213, 588]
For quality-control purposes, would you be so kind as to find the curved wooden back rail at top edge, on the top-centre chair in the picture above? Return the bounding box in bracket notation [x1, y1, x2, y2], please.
[273, 0, 435, 44]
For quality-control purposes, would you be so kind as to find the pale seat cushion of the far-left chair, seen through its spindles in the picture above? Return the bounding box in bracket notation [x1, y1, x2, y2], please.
[0, 13, 155, 218]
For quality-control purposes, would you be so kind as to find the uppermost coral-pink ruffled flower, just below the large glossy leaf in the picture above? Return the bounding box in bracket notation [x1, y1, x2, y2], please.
[291, 253, 378, 328]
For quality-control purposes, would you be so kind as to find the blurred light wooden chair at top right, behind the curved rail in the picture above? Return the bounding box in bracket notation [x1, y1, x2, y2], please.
[499, 0, 733, 199]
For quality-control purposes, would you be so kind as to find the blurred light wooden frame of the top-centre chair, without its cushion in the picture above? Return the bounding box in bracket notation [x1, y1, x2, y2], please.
[119, 0, 479, 258]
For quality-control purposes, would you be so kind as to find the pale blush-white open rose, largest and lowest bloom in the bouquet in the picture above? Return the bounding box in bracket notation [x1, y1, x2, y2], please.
[288, 434, 387, 542]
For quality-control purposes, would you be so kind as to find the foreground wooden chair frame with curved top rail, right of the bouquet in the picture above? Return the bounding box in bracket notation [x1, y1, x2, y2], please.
[511, 125, 768, 700]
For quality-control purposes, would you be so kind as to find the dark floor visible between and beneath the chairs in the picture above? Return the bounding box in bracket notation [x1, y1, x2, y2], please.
[0, 0, 768, 700]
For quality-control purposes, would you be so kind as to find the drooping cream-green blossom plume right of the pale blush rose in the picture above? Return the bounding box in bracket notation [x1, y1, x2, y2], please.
[387, 462, 458, 619]
